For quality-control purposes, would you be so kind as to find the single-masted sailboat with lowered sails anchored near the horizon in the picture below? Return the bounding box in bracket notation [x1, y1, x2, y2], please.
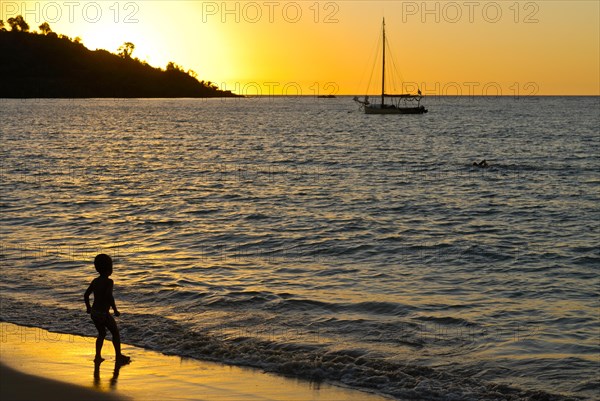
[354, 18, 427, 114]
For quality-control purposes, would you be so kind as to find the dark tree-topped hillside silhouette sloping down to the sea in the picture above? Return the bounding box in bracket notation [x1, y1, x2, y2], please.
[0, 16, 238, 98]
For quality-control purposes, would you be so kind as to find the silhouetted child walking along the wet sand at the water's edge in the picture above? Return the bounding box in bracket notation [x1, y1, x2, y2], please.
[83, 253, 130, 364]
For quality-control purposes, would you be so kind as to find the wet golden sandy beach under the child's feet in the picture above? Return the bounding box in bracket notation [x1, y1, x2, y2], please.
[0, 322, 387, 401]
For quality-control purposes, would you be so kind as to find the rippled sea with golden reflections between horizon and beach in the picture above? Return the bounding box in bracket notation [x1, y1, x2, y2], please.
[0, 96, 600, 401]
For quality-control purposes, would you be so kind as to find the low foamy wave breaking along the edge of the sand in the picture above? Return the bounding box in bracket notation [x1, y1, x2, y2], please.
[0, 297, 569, 401]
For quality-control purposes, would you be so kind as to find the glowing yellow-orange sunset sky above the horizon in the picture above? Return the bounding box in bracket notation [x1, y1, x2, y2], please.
[0, 0, 600, 95]
